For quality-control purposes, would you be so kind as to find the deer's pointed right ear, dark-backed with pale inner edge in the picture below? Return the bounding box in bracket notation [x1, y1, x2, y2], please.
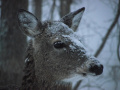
[60, 7, 85, 31]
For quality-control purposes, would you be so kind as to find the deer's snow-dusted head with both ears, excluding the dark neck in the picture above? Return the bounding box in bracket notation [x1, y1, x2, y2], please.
[18, 8, 103, 88]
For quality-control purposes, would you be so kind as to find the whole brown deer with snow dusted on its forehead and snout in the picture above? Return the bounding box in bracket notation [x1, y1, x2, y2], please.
[17, 7, 103, 90]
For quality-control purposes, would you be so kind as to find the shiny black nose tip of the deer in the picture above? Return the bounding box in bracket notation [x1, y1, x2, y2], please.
[89, 65, 103, 75]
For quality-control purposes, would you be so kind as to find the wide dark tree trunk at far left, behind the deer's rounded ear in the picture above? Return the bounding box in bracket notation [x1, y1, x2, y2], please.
[0, 0, 28, 86]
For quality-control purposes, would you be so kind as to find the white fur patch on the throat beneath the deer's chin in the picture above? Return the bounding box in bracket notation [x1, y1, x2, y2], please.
[62, 74, 84, 89]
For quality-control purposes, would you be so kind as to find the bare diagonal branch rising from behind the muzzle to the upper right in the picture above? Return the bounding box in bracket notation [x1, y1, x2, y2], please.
[95, 0, 120, 57]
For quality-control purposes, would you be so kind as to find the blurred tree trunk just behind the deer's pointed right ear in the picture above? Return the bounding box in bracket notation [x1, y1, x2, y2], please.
[60, 0, 72, 17]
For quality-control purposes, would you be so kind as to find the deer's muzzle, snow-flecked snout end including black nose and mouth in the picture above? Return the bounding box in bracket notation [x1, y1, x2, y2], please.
[76, 57, 103, 75]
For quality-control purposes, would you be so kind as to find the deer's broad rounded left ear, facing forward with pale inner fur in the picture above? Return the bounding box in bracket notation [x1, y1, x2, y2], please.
[17, 9, 40, 37]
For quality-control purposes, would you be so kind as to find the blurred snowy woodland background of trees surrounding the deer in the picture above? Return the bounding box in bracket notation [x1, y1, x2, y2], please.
[0, 0, 120, 90]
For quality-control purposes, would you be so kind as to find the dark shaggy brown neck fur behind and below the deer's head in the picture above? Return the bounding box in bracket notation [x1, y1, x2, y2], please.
[20, 40, 71, 90]
